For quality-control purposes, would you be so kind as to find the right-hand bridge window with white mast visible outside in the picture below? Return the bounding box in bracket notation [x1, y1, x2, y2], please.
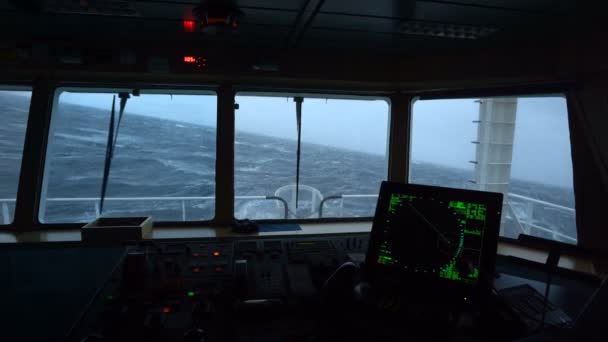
[409, 96, 577, 244]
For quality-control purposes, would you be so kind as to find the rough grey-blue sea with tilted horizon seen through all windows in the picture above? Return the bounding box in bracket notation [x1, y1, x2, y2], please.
[0, 93, 576, 243]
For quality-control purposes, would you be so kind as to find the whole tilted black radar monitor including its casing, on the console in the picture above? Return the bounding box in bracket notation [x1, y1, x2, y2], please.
[366, 182, 503, 294]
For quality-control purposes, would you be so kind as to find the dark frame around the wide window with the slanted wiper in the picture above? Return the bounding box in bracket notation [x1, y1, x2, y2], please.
[34, 83, 220, 230]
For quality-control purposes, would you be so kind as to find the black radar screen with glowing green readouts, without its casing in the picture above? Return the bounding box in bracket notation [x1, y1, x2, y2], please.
[377, 194, 487, 285]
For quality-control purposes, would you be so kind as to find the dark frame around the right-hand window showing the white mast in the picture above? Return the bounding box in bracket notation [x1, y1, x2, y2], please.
[404, 91, 582, 246]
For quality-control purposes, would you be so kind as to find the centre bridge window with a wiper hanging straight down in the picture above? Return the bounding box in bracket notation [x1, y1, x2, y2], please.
[235, 94, 389, 219]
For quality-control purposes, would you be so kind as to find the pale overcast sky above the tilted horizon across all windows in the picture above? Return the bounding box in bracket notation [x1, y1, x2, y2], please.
[60, 92, 572, 187]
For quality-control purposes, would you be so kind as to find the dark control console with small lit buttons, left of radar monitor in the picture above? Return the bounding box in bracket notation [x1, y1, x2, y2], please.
[68, 234, 368, 342]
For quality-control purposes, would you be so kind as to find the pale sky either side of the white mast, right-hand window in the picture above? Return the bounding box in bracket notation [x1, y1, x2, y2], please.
[411, 97, 572, 187]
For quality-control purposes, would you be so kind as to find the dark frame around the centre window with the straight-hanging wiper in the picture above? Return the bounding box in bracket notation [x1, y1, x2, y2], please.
[232, 88, 394, 224]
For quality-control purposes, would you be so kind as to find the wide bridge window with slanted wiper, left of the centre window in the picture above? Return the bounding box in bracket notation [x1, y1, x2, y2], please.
[39, 88, 217, 223]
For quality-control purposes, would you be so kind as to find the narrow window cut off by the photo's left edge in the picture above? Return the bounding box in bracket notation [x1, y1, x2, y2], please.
[0, 88, 32, 225]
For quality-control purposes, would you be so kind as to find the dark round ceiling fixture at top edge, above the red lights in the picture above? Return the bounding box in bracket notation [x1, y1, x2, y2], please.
[192, 0, 243, 35]
